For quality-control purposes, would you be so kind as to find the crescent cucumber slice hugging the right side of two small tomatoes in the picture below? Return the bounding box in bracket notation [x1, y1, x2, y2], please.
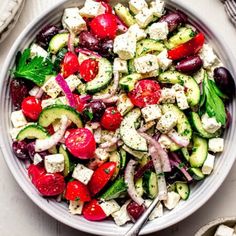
[86, 58, 112, 94]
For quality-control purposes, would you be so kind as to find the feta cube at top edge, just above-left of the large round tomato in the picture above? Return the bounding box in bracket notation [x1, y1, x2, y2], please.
[79, 0, 106, 18]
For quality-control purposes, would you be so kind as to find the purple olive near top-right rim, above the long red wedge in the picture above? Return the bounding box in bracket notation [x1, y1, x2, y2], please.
[159, 11, 187, 32]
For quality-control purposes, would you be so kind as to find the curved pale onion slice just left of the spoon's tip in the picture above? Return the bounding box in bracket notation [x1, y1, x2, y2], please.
[125, 159, 144, 206]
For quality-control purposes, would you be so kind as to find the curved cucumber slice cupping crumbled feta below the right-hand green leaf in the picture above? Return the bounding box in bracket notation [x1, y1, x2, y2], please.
[190, 112, 222, 139]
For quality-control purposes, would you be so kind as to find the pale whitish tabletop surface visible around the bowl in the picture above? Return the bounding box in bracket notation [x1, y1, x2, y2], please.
[0, 0, 236, 236]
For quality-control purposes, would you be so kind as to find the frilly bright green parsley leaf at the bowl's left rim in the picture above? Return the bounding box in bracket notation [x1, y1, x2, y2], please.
[13, 48, 54, 86]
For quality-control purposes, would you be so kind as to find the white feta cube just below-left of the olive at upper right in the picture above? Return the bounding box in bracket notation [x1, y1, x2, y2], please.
[147, 22, 169, 40]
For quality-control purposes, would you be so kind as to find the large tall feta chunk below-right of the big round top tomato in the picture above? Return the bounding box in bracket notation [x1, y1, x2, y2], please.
[113, 31, 136, 60]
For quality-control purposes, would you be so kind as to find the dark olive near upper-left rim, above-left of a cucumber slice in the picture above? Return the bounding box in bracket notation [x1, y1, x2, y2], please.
[36, 25, 59, 48]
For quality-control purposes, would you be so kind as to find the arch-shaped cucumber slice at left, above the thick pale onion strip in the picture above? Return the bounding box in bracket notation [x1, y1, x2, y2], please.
[38, 104, 83, 128]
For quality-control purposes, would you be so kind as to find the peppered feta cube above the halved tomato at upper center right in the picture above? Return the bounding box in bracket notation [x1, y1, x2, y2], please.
[134, 54, 159, 74]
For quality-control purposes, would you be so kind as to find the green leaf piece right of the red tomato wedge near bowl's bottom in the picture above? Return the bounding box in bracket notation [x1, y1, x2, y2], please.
[100, 178, 127, 201]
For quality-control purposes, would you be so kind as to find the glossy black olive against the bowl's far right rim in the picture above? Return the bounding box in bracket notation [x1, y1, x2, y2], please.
[213, 67, 235, 97]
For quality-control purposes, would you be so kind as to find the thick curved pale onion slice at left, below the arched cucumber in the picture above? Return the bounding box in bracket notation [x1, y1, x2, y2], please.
[35, 115, 68, 152]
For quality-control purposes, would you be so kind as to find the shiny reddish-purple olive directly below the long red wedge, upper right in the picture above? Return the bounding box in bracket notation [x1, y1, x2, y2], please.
[175, 56, 203, 74]
